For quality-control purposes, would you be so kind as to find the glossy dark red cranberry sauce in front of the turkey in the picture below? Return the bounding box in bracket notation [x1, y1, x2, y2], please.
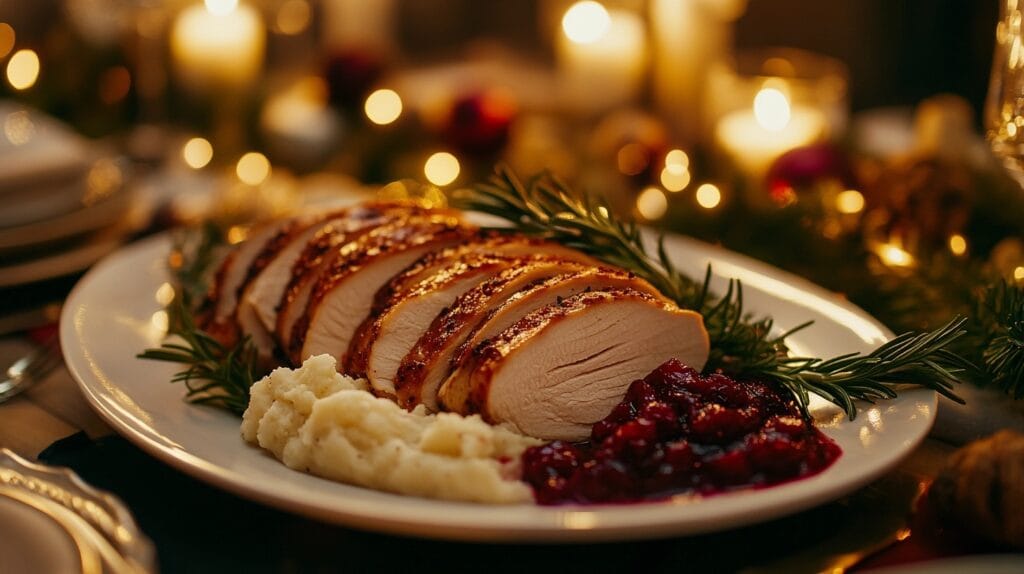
[522, 359, 840, 504]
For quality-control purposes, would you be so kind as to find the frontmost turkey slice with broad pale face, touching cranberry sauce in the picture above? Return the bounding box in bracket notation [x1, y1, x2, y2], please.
[452, 289, 709, 441]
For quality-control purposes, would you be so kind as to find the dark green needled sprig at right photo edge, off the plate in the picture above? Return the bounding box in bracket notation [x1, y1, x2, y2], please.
[976, 280, 1024, 399]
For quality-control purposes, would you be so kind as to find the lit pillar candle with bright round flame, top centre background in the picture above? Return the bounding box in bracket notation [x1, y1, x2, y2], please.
[557, 1, 647, 114]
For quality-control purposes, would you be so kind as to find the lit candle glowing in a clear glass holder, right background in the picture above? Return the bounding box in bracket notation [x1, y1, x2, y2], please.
[715, 82, 826, 179]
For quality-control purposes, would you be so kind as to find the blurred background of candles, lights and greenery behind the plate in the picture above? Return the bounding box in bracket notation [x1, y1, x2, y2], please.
[0, 0, 1024, 343]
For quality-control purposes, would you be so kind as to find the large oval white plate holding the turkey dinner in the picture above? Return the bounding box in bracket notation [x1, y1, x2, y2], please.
[60, 230, 936, 542]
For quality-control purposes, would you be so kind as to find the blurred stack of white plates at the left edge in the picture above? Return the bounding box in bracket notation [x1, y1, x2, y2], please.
[0, 101, 145, 288]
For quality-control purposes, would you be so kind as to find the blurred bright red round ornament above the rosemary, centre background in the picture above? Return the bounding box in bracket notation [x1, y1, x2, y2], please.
[441, 91, 516, 154]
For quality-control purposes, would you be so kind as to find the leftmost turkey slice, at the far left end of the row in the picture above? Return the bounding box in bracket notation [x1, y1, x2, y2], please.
[197, 219, 291, 347]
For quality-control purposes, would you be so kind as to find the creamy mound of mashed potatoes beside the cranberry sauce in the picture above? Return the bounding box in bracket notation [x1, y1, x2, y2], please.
[242, 355, 540, 502]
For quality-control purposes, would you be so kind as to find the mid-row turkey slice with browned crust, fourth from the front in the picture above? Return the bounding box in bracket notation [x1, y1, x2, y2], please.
[348, 254, 522, 397]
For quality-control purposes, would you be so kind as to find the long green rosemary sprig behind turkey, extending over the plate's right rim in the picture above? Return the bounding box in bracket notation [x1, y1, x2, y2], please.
[452, 167, 975, 420]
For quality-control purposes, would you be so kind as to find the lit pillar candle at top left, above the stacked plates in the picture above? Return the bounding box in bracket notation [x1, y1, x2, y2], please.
[171, 0, 266, 94]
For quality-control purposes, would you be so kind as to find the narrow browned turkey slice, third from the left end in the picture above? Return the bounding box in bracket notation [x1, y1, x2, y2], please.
[272, 203, 440, 355]
